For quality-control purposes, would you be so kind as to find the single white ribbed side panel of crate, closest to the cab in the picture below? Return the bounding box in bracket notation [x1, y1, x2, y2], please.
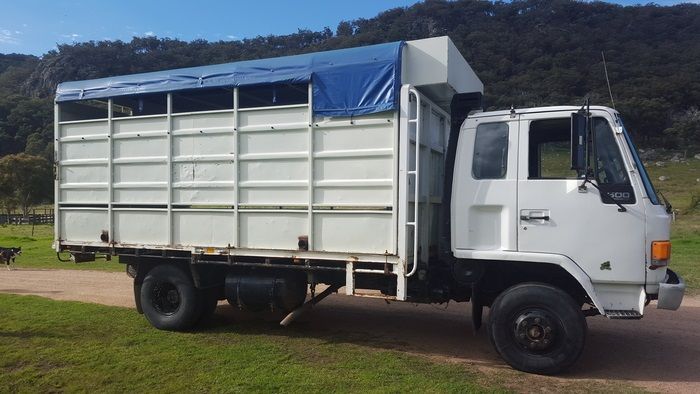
[312, 112, 398, 254]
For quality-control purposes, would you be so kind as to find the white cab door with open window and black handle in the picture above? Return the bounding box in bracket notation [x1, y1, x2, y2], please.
[517, 111, 645, 290]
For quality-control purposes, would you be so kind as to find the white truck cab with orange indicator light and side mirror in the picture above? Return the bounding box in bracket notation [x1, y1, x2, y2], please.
[451, 106, 685, 372]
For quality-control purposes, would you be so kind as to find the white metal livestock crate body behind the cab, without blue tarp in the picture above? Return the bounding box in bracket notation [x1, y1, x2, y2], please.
[55, 37, 483, 299]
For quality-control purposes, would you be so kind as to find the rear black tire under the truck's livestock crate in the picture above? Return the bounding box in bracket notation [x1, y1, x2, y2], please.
[141, 264, 201, 331]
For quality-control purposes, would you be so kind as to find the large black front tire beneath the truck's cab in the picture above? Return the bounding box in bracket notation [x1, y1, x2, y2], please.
[488, 283, 587, 375]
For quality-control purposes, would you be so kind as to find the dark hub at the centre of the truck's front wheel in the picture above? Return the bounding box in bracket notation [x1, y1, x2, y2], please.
[514, 310, 556, 351]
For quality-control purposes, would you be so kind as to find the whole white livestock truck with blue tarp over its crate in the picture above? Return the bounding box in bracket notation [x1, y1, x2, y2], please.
[54, 37, 685, 374]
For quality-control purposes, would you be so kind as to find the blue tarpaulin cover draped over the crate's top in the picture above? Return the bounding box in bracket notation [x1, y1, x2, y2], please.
[56, 42, 403, 116]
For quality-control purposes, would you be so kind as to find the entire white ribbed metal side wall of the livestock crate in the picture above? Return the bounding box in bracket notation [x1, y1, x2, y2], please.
[57, 83, 399, 256]
